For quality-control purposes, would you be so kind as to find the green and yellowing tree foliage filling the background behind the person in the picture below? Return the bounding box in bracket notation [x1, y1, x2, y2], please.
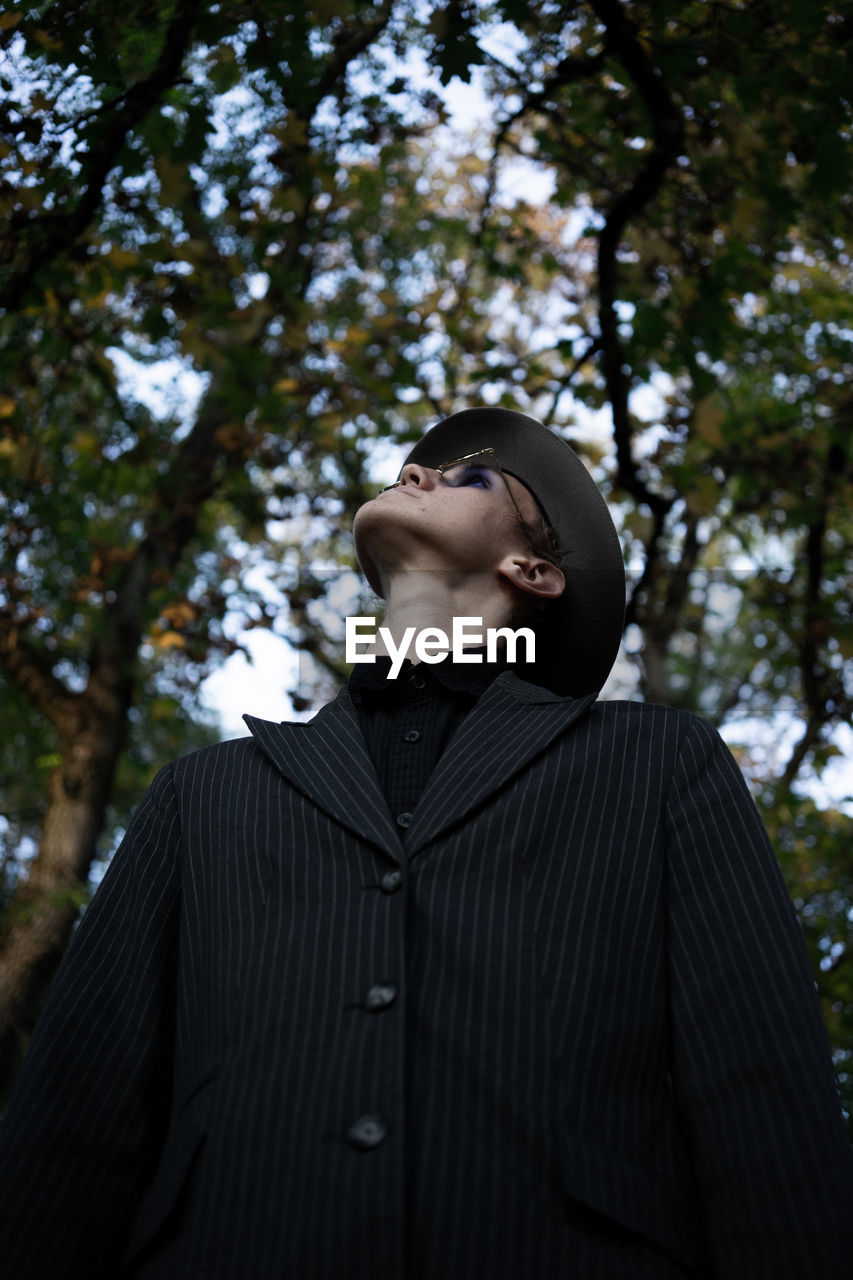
[0, 0, 853, 1121]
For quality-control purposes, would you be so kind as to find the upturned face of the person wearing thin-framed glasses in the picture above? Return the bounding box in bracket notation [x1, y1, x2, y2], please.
[353, 453, 539, 594]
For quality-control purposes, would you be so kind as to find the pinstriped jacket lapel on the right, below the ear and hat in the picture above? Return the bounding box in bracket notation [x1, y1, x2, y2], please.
[406, 672, 596, 856]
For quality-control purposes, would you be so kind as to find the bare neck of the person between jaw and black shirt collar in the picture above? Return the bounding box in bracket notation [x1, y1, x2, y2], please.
[375, 570, 512, 662]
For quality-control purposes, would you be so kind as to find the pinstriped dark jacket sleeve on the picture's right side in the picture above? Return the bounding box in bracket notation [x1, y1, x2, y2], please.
[667, 719, 853, 1280]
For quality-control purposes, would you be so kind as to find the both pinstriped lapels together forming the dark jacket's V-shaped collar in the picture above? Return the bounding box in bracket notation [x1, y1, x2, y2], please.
[243, 671, 596, 863]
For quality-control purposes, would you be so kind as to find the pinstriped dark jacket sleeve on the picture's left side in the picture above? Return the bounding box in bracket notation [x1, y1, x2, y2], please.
[0, 769, 179, 1280]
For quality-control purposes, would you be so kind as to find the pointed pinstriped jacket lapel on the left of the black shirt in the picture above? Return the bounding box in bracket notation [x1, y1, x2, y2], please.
[243, 689, 405, 863]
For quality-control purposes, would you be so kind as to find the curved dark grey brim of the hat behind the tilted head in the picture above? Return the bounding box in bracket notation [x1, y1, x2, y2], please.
[406, 407, 625, 698]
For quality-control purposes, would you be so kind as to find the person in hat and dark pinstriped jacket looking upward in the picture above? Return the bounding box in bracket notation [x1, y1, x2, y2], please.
[0, 408, 853, 1280]
